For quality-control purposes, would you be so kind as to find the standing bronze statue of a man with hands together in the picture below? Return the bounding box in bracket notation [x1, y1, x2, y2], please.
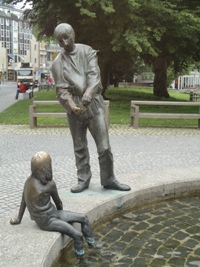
[52, 23, 131, 193]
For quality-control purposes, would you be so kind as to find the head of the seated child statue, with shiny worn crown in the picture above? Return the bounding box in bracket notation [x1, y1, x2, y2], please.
[31, 151, 52, 184]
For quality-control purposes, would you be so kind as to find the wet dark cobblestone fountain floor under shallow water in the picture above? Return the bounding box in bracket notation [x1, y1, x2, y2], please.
[53, 197, 200, 267]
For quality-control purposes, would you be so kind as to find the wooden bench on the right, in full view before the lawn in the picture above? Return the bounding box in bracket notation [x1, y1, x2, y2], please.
[130, 100, 200, 128]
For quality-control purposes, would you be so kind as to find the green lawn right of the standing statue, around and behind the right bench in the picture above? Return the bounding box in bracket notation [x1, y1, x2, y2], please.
[106, 88, 198, 127]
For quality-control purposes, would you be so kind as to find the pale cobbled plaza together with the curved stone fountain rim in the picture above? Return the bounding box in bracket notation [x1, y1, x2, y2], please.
[0, 125, 200, 267]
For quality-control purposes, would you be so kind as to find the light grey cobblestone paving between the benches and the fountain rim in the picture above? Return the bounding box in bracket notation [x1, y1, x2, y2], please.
[0, 125, 200, 217]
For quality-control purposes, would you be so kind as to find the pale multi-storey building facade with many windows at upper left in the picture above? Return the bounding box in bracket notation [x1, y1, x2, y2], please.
[0, 0, 40, 81]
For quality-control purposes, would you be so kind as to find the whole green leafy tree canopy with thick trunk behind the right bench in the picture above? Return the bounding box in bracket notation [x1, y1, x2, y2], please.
[4, 0, 200, 97]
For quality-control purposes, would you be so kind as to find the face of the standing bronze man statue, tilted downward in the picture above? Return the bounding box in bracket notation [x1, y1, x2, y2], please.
[57, 30, 74, 52]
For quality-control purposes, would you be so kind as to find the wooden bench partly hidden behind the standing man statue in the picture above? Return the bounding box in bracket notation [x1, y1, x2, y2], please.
[29, 100, 109, 128]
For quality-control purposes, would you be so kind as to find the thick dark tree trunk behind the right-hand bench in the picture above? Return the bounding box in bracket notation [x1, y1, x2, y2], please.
[153, 55, 170, 98]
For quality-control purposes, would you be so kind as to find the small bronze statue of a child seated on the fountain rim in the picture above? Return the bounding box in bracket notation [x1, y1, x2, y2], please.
[10, 151, 95, 256]
